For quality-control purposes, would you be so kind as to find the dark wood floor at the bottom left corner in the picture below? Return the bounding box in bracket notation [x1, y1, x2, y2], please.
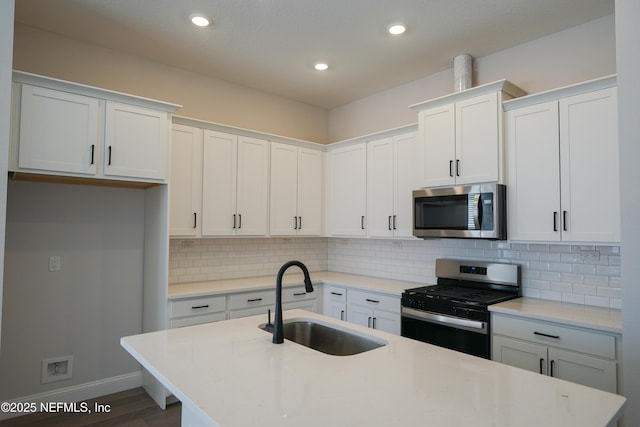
[0, 388, 181, 427]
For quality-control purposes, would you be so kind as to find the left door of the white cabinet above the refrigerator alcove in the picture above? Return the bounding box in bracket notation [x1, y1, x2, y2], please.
[18, 85, 99, 175]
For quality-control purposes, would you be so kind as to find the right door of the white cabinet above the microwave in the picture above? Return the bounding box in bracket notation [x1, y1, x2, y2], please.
[455, 92, 502, 184]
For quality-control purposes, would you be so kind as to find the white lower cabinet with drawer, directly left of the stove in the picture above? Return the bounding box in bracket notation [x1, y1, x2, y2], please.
[347, 290, 400, 335]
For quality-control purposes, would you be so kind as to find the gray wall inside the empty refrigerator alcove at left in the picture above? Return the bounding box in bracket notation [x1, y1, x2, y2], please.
[0, 181, 145, 400]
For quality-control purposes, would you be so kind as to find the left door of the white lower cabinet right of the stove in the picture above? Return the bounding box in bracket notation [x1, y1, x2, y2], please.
[491, 335, 547, 375]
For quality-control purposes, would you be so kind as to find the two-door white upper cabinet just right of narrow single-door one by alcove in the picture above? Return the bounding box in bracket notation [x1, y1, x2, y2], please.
[202, 130, 269, 236]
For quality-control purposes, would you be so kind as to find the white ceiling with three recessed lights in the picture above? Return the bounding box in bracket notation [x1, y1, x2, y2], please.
[16, 0, 614, 108]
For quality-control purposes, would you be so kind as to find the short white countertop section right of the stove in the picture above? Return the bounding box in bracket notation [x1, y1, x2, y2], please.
[489, 298, 622, 334]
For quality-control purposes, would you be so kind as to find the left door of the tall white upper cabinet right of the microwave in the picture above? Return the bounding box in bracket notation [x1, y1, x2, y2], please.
[507, 101, 561, 241]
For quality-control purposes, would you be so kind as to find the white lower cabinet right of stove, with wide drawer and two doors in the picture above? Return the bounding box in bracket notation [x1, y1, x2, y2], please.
[491, 313, 618, 393]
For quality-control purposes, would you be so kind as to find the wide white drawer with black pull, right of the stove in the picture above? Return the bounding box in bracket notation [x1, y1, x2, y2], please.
[491, 313, 616, 359]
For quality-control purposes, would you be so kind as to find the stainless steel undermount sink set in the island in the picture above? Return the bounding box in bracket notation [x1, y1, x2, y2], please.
[259, 319, 387, 356]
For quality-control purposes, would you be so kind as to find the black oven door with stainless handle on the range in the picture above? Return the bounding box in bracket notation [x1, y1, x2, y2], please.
[401, 307, 491, 359]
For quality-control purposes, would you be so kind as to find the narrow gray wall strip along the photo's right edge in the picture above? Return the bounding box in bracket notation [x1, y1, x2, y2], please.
[616, 0, 640, 426]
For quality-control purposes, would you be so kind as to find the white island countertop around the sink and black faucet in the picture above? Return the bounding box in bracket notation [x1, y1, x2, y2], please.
[121, 310, 626, 427]
